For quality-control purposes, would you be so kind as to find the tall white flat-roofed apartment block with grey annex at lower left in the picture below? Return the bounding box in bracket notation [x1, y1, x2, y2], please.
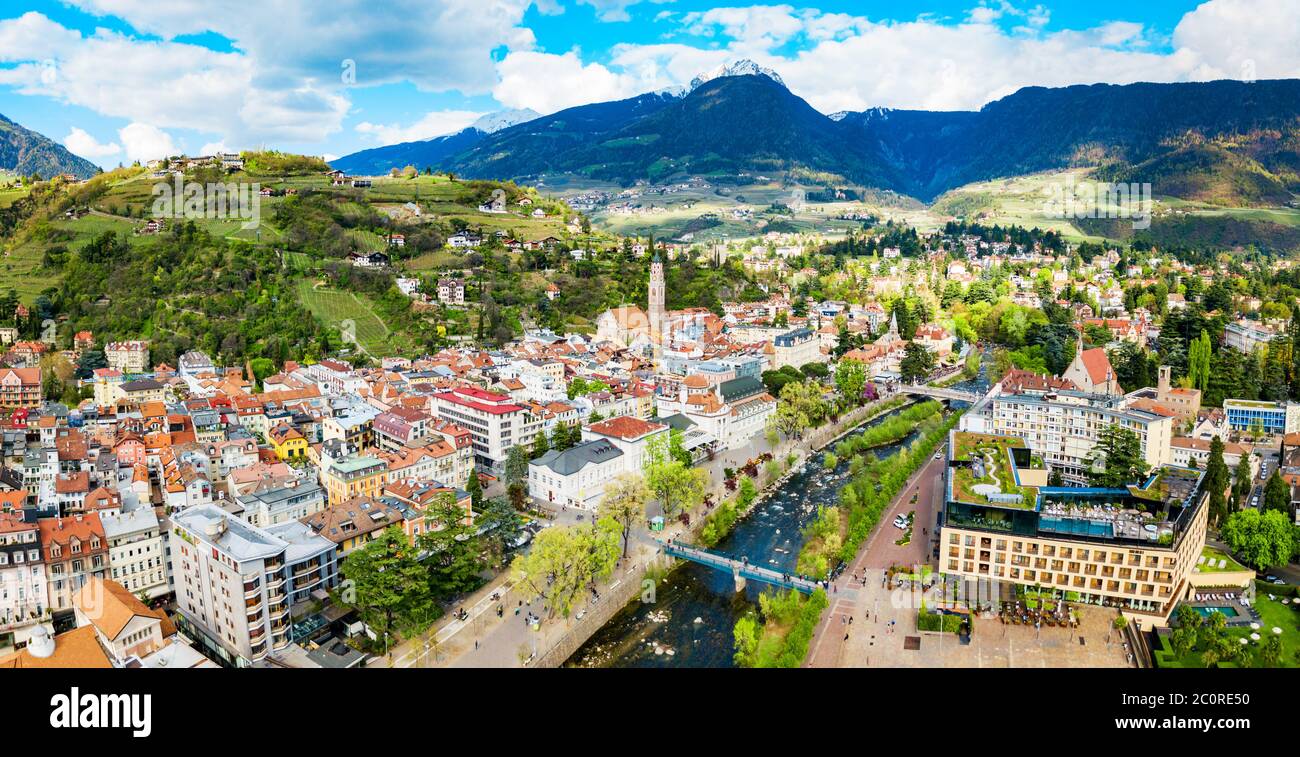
[172, 505, 338, 667]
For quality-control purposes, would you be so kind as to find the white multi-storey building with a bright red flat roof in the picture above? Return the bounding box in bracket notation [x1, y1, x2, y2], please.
[433, 386, 546, 472]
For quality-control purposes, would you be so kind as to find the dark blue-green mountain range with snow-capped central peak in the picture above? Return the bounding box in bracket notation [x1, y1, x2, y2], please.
[333, 61, 1300, 204]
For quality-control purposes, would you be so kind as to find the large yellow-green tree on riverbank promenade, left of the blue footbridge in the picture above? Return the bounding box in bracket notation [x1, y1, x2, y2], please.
[511, 518, 619, 618]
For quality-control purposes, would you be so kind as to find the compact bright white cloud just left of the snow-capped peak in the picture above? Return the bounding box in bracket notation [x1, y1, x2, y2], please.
[491, 51, 645, 113]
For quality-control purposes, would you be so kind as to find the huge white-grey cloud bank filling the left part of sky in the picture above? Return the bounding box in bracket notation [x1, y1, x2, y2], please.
[0, 0, 534, 147]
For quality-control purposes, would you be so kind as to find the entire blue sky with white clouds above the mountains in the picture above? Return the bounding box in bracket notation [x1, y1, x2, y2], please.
[0, 0, 1300, 166]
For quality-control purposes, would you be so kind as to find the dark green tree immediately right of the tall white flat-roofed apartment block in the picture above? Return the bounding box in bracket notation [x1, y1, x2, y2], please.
[342, 525, 434, 647]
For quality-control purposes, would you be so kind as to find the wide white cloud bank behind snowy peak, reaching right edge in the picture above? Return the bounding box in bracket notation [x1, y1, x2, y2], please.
[603, 0, 1300, 113]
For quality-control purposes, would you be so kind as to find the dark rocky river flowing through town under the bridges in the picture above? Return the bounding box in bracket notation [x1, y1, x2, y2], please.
[566, 371, 987, 667]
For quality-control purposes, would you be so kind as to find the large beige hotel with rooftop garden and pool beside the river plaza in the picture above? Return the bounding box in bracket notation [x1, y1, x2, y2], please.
[939, 431, 1208, 630]
